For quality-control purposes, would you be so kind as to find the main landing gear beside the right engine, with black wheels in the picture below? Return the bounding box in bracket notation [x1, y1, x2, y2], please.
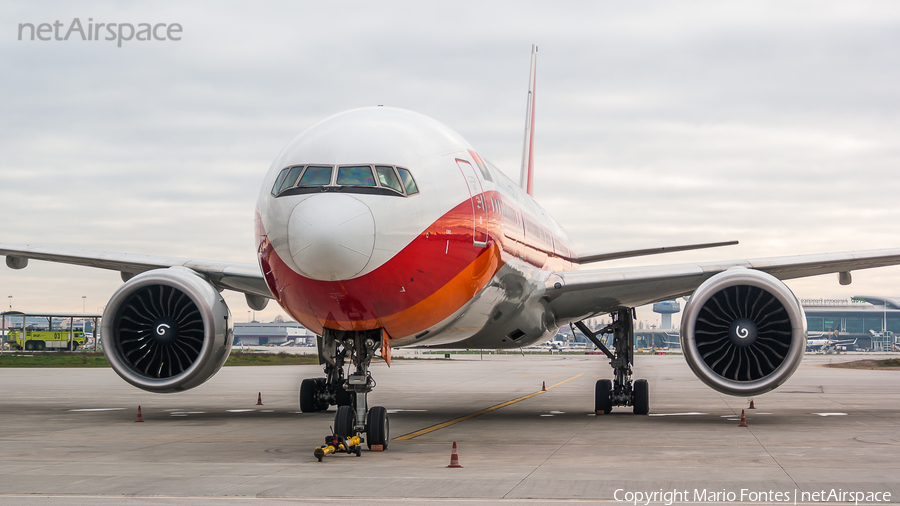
[575, 309, 650, 415]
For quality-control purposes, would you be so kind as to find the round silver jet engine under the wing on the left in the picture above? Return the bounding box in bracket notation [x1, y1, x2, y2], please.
[101, 267, 234, 393]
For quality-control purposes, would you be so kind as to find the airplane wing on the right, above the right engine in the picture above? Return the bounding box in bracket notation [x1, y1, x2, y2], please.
[546, 249, 900, 322]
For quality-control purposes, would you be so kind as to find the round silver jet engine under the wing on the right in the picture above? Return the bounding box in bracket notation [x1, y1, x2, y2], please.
[681, 267, 806, 396]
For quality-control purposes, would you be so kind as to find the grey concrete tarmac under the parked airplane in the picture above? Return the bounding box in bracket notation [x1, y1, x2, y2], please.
[0, 354, 900, 505]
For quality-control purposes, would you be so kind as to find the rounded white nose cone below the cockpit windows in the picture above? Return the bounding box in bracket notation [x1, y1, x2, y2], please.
[288, 193, 375, 281]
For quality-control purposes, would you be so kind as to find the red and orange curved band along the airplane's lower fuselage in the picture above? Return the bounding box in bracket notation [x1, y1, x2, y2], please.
[256, 188, 571, 338]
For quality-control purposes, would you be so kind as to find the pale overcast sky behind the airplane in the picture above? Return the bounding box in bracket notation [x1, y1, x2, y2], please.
[0, 0, 900, 321]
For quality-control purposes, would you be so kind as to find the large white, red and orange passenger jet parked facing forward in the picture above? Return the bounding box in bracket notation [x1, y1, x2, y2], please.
[0, 48, 900, 447]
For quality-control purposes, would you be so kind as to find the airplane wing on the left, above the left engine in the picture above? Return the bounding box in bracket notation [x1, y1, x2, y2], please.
[0, 243, 272, 298]
